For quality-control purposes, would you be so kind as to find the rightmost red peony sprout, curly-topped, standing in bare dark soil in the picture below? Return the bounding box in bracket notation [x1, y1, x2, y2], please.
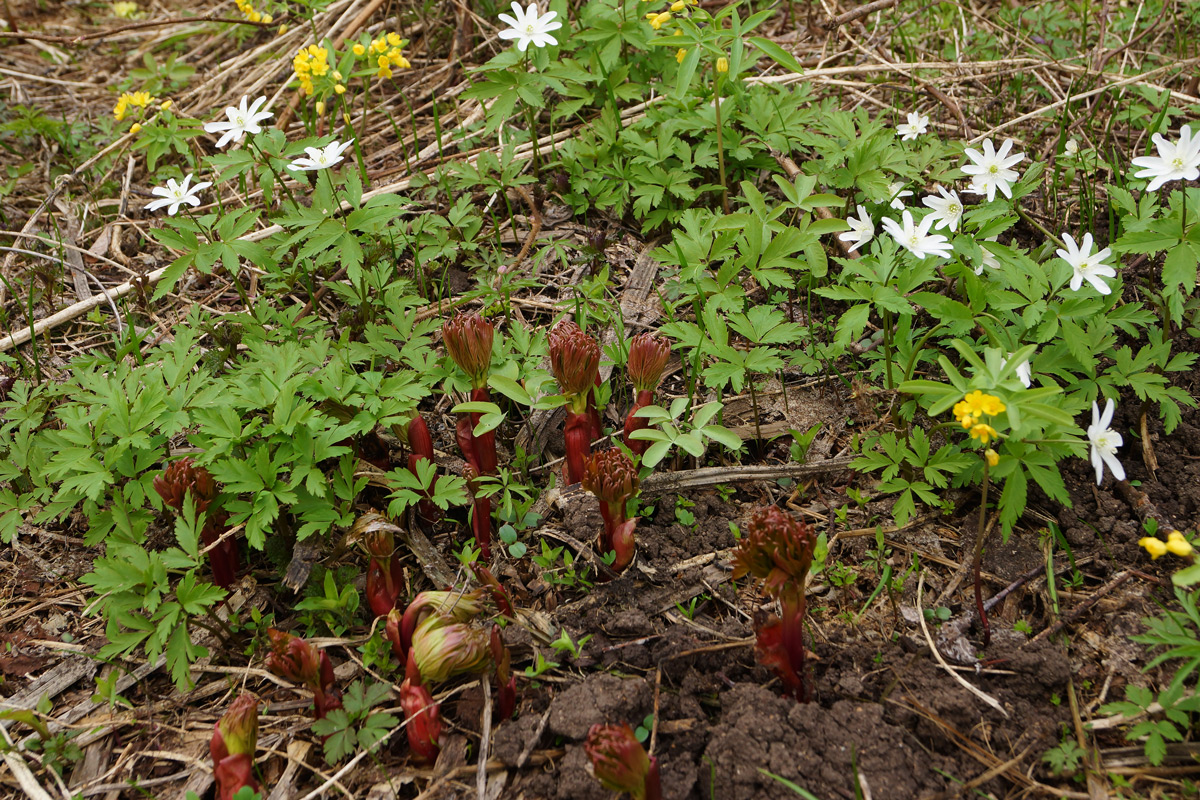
[733, 506, 817, 703]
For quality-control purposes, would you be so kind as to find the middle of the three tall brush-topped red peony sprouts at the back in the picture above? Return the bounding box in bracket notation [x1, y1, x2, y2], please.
[550, 319, 601, 483]
